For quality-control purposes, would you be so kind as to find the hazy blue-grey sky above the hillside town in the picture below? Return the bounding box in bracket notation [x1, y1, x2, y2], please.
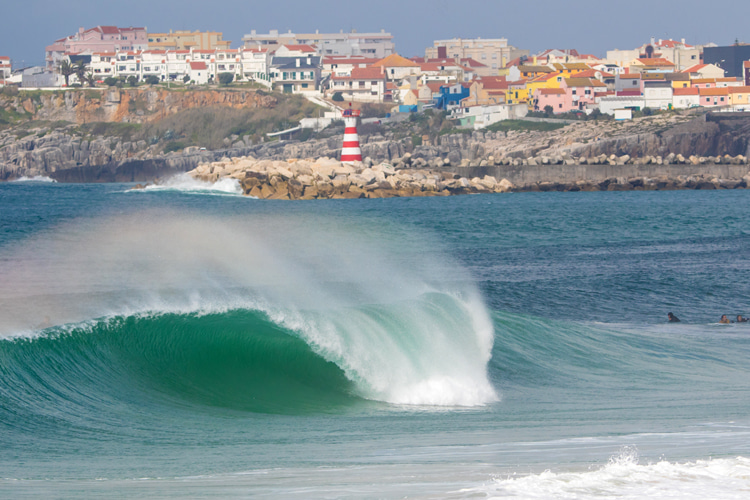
[0, 0, 750, 66]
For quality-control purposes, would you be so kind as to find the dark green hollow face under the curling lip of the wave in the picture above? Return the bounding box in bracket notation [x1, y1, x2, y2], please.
[0, 310, 358, 416]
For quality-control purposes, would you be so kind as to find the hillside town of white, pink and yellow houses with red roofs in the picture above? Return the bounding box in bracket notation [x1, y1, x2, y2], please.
[0, 26, 750, 129]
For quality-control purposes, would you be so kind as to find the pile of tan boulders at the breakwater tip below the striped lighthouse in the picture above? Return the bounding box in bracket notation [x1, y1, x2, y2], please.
[188, 157, 514, 200]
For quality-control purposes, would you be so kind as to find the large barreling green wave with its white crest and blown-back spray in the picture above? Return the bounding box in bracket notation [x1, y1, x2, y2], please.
[0, 209, 497, 420]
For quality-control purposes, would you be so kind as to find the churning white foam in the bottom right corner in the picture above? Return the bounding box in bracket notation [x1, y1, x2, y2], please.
[461, 448, 750, 500]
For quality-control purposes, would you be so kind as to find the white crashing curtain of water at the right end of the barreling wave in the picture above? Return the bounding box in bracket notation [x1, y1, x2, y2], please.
[280, 292, 498, 407]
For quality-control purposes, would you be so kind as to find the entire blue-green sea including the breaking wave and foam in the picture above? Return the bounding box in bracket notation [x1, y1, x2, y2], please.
[0, 179, 750, 499]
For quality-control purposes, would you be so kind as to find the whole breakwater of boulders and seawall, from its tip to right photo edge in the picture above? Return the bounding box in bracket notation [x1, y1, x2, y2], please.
[188, 155, 750, 200]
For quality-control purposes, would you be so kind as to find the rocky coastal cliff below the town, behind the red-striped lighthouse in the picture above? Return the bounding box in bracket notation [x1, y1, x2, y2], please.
[0, 88, 750, 186]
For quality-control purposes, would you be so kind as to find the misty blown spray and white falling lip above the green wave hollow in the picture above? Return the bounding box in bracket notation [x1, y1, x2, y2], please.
[0, 212, 497, 406]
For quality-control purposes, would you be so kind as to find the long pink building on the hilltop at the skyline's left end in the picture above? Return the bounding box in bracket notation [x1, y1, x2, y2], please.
[45, 26, 148, 69]
